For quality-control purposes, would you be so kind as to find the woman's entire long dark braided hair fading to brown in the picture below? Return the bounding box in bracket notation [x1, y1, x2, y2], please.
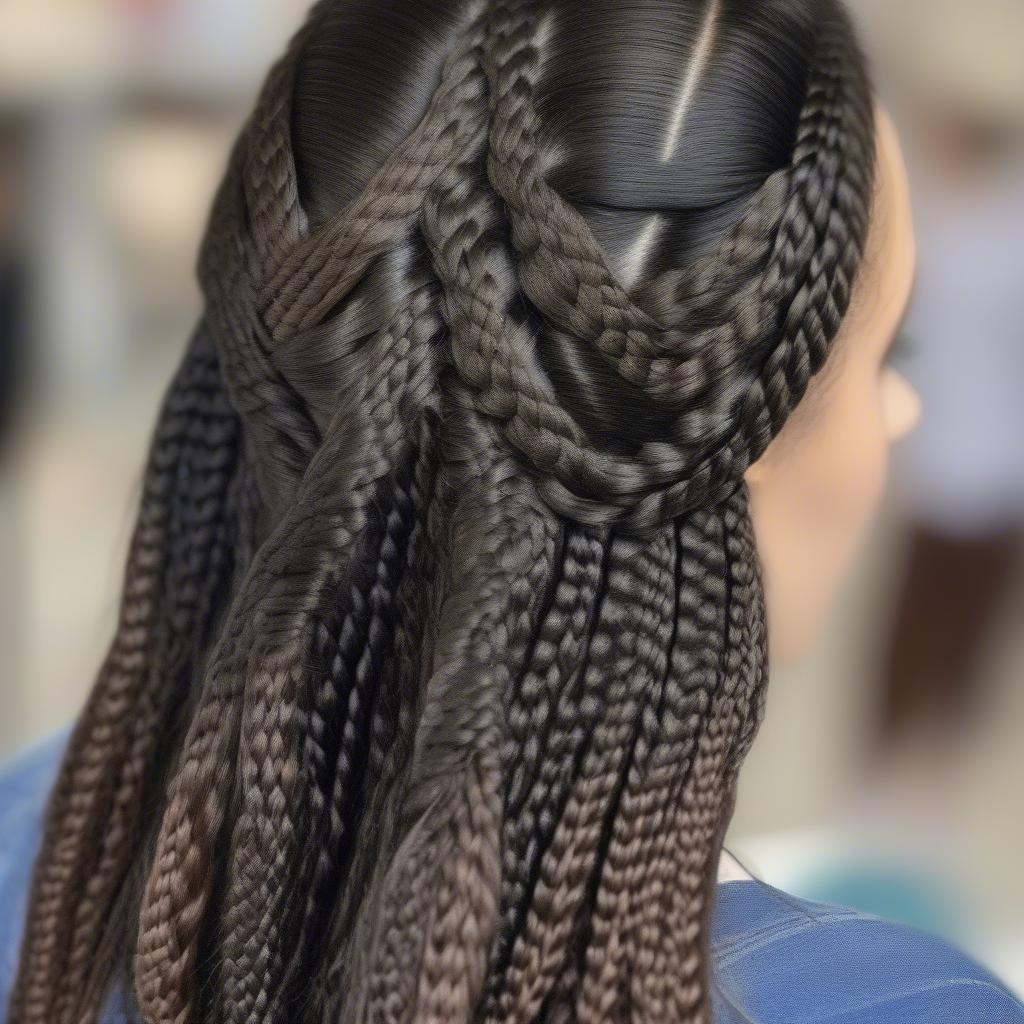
[9, 0, 873, 1024]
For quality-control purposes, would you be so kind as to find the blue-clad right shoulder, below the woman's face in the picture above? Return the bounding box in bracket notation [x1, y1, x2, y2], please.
[712, 881, 1024, 1024]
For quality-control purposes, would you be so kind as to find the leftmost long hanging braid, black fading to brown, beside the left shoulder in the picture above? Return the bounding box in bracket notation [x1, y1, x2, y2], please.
[12, 329, 237, 1022]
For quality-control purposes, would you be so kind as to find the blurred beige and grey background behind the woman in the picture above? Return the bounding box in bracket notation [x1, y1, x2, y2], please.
[0, 0, 1024, 993]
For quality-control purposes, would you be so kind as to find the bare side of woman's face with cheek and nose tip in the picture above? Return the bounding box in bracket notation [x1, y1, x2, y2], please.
[746, 103, 920, 664]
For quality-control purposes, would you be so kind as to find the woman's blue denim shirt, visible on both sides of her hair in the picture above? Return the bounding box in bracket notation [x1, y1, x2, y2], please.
[0, 733, 1024, 1024]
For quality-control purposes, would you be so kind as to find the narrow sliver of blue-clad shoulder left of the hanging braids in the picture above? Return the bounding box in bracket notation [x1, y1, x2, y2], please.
[0, 730, 68, 1020]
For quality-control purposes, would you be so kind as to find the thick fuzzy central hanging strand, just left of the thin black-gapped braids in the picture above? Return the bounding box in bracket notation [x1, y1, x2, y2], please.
[329, 428, 553, 1020]
